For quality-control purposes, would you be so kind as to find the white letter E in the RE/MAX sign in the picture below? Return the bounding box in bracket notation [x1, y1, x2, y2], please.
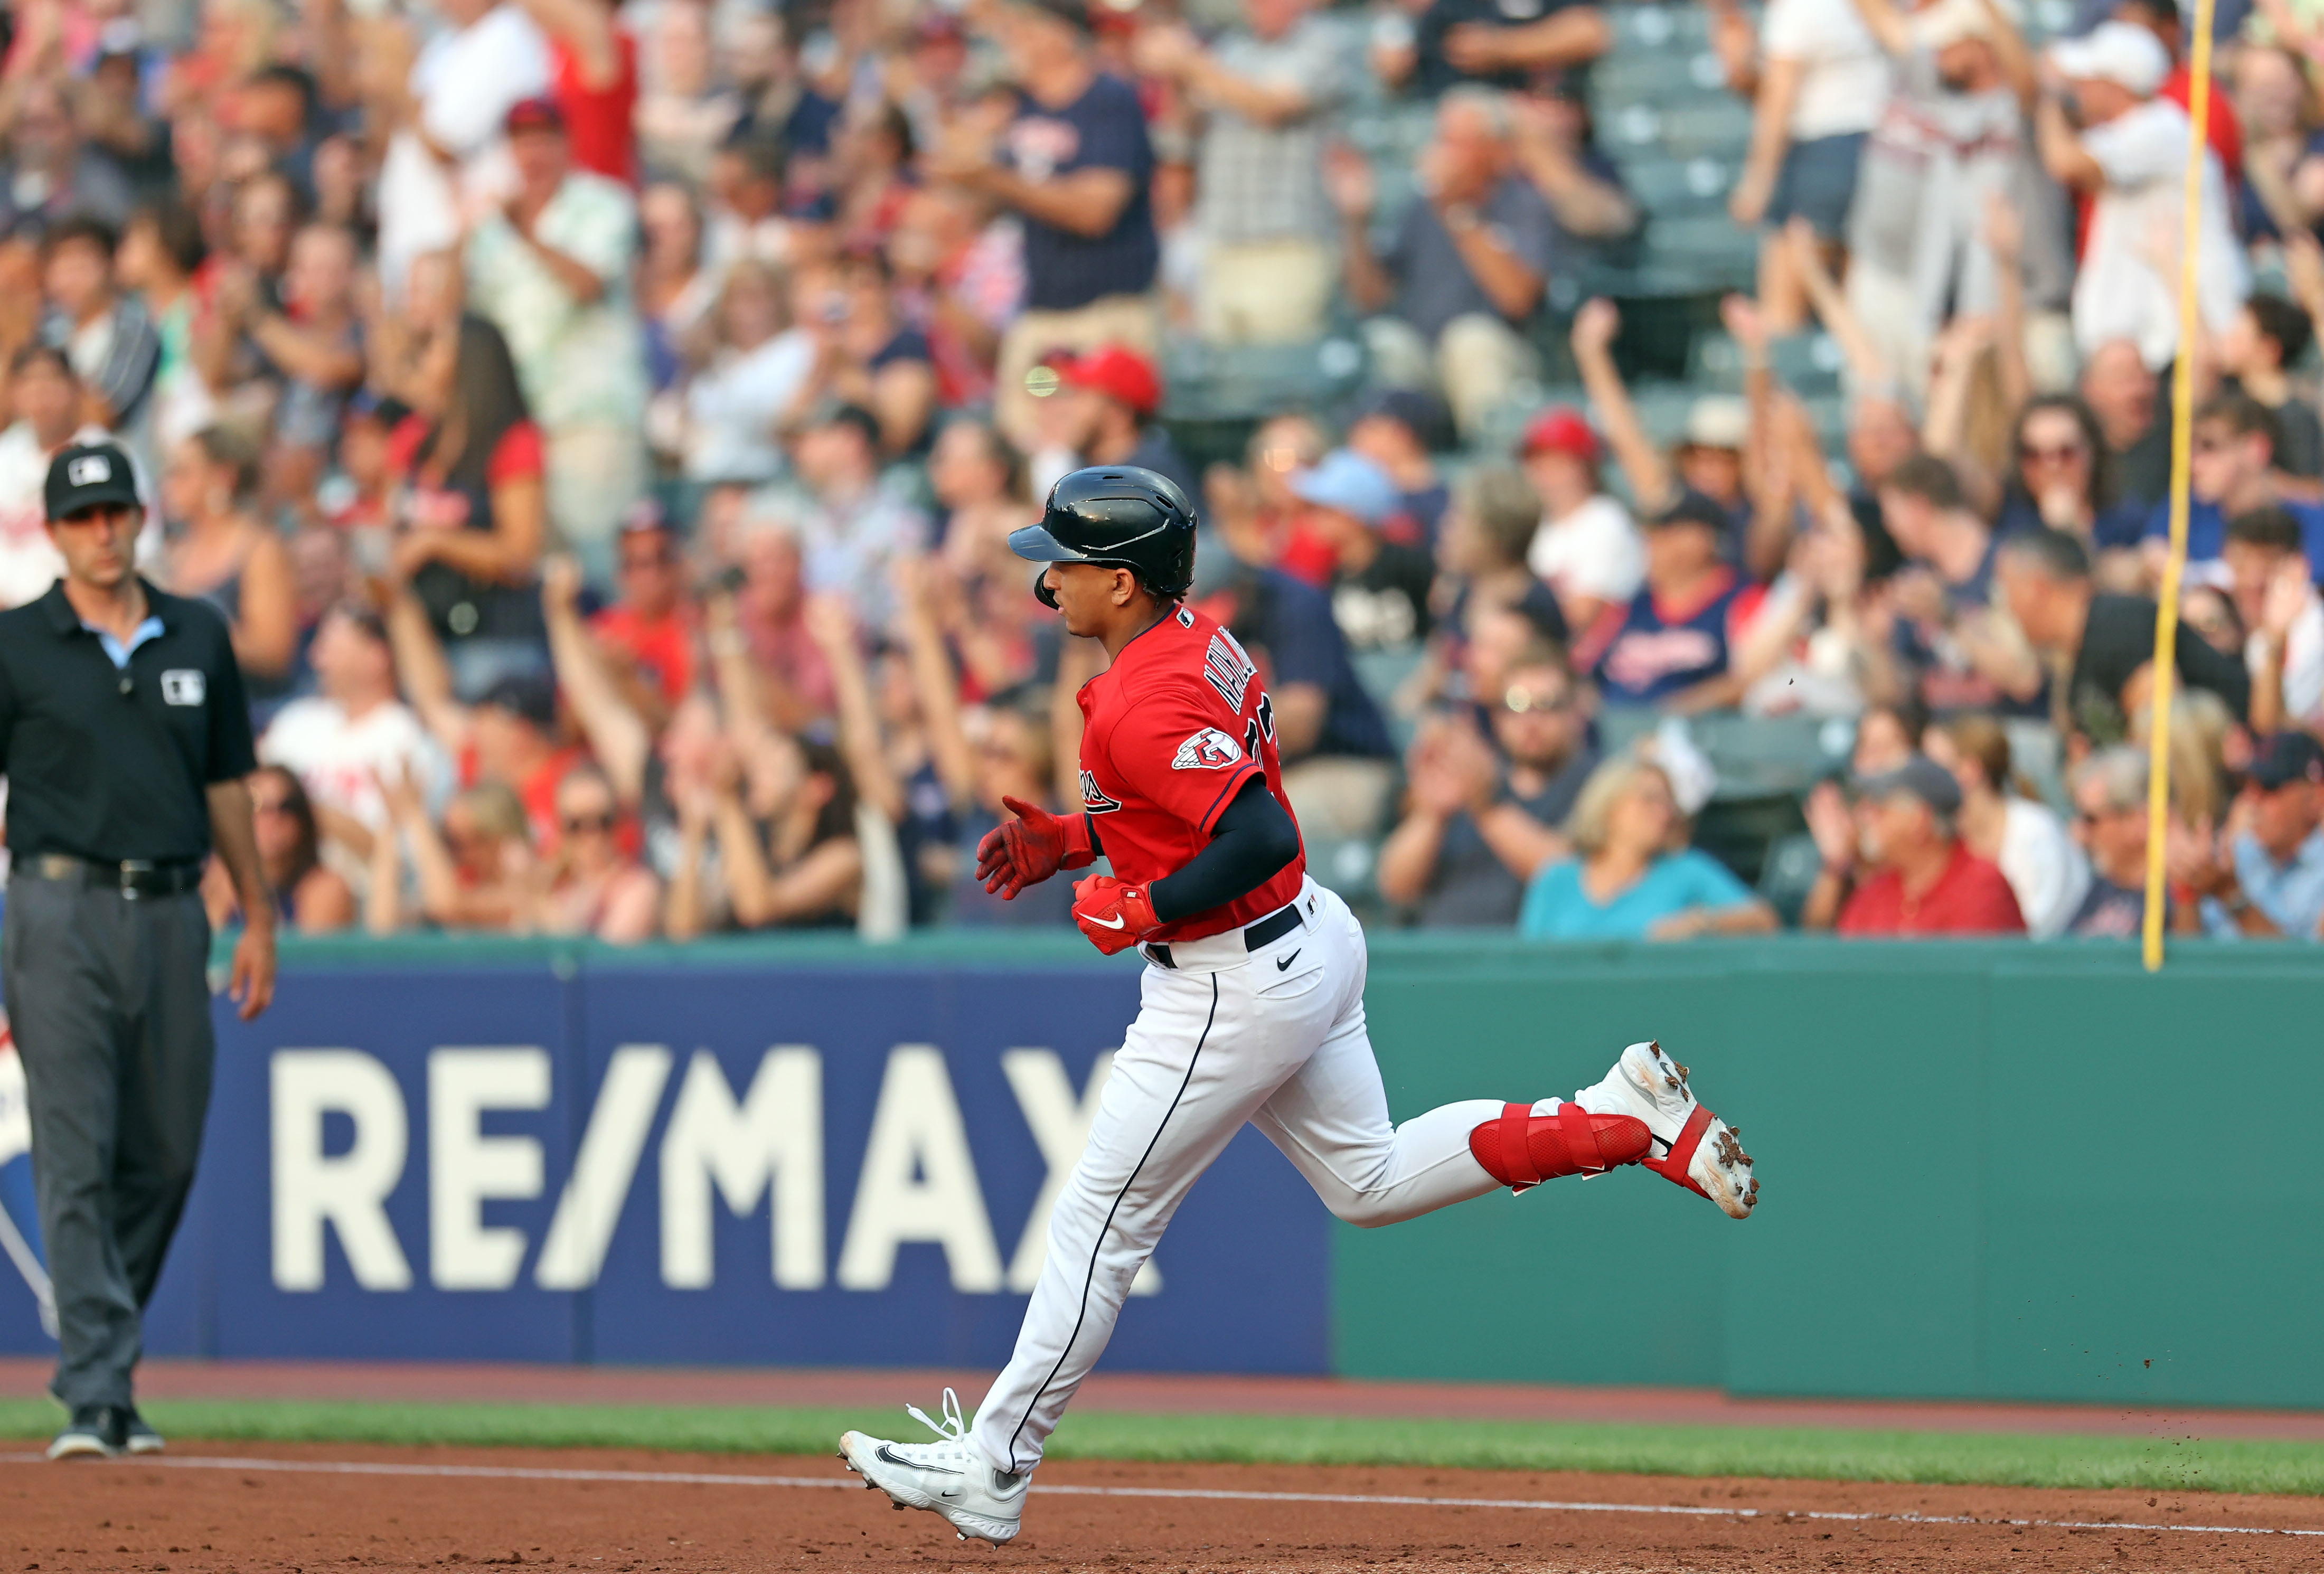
[428, 1044, 549, 1290]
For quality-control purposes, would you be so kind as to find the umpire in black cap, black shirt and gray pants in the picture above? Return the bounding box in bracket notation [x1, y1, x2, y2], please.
[0, 442, 274, 1460]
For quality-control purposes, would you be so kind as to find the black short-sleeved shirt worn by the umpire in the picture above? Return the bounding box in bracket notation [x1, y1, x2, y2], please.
[0, 581, 258, 863]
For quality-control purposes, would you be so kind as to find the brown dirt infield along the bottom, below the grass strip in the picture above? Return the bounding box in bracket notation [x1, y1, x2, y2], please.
[0, 1441, 2324, 1574]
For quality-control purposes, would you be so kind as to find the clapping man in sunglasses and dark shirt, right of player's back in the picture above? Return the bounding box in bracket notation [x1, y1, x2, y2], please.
[1378, 644, 1596, 928]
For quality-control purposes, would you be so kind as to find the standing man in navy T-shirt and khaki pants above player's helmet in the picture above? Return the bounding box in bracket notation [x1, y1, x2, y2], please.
[943, 0, 1160, 449]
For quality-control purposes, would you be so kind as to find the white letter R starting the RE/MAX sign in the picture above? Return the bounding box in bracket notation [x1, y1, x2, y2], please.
[267, 1049, 411, 1290]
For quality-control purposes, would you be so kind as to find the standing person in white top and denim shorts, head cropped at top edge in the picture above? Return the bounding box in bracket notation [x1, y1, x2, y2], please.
[1727, 0, 1889, 333]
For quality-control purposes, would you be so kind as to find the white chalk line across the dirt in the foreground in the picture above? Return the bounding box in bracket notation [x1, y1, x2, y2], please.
[0, 1453, 2324, 1537]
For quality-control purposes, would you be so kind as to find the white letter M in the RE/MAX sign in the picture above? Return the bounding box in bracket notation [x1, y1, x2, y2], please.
[662, 1044, 827, 1290]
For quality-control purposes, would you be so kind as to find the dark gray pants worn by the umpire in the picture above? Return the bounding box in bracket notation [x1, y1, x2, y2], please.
[0, 870, 216, 1409]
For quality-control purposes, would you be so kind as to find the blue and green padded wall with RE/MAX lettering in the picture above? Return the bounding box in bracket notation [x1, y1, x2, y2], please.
[0, 935, 2324, 1407]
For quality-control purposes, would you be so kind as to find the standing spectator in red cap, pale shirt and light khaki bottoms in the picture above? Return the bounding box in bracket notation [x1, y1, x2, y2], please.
[467, 98, 646, 583]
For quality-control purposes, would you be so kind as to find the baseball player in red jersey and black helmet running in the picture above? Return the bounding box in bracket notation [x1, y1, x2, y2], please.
[839, 465, 1760, 1546]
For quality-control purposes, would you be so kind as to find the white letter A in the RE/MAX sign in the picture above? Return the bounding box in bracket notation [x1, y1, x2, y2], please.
[839, 1044, 1002, 1295]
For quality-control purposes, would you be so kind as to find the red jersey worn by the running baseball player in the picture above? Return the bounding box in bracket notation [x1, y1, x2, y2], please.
[1080, 607, 1306, 939]
